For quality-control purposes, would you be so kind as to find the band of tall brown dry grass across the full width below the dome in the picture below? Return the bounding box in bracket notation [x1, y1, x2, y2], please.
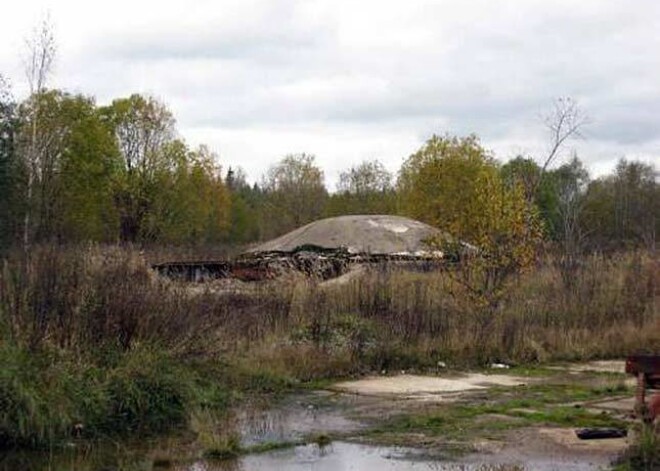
[0, 247, 660, 368]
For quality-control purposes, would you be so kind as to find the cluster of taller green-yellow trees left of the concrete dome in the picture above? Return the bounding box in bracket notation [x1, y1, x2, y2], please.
[0, 90, 229, 244]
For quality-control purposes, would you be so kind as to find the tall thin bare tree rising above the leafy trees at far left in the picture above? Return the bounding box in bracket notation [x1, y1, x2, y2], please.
[23, 16, 56, 252]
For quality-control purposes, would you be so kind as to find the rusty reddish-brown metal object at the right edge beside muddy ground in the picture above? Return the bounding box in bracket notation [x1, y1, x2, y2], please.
[626, 355, 660, 423]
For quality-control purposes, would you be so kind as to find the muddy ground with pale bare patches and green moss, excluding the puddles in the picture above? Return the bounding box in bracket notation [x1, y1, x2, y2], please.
[318, 361, 635, 469]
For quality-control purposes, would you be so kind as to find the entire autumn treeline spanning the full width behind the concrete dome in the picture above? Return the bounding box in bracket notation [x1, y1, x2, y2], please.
[0, 85, 660, 252]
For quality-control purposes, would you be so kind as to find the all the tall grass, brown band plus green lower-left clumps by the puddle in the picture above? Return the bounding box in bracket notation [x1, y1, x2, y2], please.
[0, 247, 660, 445]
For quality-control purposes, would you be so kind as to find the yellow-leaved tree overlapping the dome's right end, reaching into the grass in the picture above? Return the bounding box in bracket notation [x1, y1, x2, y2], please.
[399, 136, 541, 360]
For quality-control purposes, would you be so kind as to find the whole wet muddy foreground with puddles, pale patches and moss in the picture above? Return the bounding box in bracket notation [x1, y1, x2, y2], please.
[0, 362, 648, 471]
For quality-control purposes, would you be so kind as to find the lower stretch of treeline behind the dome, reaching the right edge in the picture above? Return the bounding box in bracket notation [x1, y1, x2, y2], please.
[160, 132, 660, 253]
